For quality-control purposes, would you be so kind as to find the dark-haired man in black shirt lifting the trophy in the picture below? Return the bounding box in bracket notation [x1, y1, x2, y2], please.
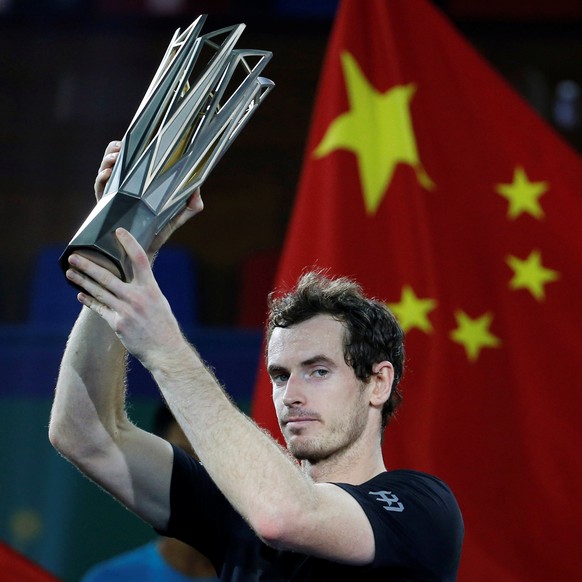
[50, 146, 463, 581]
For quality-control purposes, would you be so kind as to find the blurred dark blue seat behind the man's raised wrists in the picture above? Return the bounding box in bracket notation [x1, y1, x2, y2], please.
[28, 244, 198, 329]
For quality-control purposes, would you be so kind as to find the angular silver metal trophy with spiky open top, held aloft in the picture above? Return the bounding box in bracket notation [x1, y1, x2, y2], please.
[59, 15, 274, 281]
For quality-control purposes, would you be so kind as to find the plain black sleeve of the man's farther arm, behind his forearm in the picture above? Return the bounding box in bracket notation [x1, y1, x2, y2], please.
[157, 445, 234, 564]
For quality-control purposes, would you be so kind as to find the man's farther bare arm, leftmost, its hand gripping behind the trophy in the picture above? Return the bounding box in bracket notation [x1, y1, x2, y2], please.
[49, 142, 202, 527]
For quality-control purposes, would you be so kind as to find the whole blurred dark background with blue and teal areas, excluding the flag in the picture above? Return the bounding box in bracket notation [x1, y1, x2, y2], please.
[0, 0, 582, 580]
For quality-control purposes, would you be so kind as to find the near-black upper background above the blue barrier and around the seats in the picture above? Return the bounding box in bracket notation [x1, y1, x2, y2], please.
[0, 0, 582, 326]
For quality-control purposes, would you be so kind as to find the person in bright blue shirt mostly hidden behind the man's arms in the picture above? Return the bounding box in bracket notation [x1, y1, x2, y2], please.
[81, 404, 218, 582]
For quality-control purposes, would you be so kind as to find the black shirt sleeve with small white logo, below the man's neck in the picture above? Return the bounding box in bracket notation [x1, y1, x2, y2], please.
[338, 471, 464, 580]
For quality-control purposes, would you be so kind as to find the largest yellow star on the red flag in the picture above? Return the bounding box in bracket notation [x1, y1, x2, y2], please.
[313, 52, 434, 214]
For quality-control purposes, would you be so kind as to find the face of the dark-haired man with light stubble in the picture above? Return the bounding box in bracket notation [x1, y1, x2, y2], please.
[267, 315, 369, 463]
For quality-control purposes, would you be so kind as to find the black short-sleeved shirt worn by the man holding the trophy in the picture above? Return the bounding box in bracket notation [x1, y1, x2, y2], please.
[160, 447, 463, 582]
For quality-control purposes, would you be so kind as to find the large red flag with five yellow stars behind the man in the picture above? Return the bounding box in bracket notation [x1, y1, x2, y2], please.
[253, 0, 582, 582]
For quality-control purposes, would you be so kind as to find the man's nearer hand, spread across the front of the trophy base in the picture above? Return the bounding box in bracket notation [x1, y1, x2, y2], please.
[66, 228, 187, 369]
